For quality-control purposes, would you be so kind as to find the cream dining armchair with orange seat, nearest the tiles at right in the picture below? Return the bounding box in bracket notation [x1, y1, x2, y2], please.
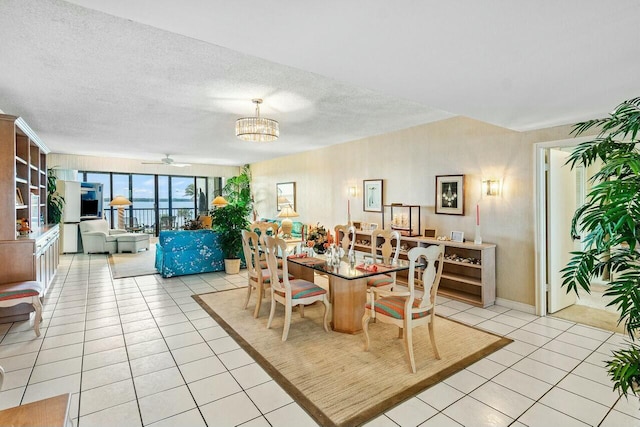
[362, 245, 444, 374]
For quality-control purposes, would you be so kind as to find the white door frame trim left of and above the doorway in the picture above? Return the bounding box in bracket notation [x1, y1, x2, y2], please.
[533, 136, 594, 316]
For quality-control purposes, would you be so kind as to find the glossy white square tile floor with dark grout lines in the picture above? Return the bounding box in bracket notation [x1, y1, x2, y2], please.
[0, 255, 640, 427]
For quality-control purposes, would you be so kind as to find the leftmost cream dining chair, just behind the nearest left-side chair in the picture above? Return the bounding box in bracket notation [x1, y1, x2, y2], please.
[242, 230, 293, 318]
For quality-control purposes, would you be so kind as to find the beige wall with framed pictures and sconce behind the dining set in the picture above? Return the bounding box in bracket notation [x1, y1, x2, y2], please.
[251, 117, 570, 306]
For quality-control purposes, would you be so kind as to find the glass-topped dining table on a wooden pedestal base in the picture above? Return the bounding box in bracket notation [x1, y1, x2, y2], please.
[287, 252, 416, 334]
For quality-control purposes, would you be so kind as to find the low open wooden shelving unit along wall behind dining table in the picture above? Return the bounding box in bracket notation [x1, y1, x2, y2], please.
[355, 230, 496, 307]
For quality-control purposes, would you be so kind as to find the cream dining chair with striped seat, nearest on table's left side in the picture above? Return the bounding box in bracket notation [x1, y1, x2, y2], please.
[261, 235, 330, 341]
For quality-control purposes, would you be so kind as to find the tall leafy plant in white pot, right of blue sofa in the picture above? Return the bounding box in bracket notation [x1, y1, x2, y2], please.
[210, 165, 252, 274]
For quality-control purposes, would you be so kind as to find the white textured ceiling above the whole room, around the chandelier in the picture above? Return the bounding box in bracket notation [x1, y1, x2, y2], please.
[0, 0, 640, 165]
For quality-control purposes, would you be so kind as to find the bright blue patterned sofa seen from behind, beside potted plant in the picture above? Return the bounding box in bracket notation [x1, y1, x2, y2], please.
[156, 230, 224, 277]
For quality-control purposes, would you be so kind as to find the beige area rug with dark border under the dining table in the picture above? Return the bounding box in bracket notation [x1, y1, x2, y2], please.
[193, 288, 511, 426]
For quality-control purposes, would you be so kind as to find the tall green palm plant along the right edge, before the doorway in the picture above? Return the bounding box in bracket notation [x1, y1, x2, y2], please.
[563, 97, 640, 396]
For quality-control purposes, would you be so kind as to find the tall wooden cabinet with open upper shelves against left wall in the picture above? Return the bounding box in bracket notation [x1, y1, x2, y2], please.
[0, 114, 60, 322]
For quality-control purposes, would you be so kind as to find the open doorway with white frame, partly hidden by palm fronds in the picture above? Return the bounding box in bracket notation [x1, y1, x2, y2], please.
[534, 138, 617, 330]
